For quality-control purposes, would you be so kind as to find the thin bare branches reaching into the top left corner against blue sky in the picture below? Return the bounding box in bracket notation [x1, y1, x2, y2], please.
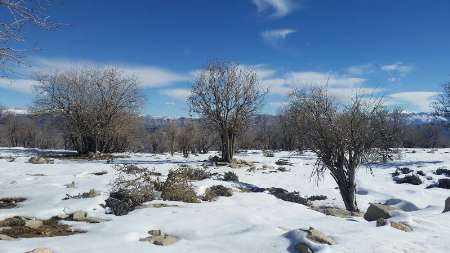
[0, 0, 57, 64]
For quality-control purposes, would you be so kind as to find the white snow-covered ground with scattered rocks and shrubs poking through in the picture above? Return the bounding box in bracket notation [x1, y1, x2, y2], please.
[0, 148, 450, 253]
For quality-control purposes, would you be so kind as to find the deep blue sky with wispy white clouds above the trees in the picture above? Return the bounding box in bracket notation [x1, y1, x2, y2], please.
[0, 0, 450, 117]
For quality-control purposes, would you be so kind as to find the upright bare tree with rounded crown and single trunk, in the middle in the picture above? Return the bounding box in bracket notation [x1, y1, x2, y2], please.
[188, 62, 266, 162]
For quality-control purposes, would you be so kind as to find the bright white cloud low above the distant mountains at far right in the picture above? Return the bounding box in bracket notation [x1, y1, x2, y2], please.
[387, 91, 439, 112]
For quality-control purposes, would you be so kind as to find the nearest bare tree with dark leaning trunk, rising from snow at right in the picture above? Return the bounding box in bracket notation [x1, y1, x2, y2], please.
[290, 88, 398, 211]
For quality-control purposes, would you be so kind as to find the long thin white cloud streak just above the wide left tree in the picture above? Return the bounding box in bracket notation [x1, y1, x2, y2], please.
[28, 58, 191, 88]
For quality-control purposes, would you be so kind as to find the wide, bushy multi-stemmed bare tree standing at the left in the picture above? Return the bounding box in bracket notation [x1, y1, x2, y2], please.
[35, 68, 142, 154]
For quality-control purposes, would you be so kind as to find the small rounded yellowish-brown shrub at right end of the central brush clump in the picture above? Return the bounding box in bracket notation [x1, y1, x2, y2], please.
[161, 168, 198, 203]
